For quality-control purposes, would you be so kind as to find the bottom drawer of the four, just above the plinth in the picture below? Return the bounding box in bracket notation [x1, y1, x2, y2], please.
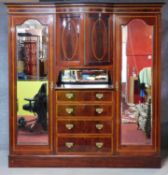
[57, 137, 112, 153]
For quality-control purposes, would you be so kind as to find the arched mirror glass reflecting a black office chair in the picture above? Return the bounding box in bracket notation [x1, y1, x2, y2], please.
[16, 20, 48, 145]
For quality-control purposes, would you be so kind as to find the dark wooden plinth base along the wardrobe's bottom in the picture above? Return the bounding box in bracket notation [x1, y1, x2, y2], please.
[9, 153, 161, 168]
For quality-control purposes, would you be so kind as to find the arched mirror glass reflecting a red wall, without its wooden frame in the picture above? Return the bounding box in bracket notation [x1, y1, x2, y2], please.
[121, 19, 153, 145]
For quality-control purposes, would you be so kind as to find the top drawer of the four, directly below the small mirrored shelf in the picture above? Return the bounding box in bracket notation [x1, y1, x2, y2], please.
[56, 91, 112, 101]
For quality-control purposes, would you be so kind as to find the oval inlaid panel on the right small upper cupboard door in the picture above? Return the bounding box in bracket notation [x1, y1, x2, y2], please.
[91, 18, 107, 60]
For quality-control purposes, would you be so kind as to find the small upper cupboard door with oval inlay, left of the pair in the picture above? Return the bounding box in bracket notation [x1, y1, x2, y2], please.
[56, 14, 83, 66]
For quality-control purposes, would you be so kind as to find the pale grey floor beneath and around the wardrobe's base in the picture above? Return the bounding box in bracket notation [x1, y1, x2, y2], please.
[0, 149, 168, 175]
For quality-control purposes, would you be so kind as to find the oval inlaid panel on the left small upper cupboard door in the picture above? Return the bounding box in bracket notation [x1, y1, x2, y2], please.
[61, 20, 78, 60]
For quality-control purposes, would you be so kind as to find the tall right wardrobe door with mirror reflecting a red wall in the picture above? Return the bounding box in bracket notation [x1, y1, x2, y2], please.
[116, 15, 160, 154]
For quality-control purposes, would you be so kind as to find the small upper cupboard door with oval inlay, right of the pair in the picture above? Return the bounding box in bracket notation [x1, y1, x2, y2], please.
[85, 13, 112, 65]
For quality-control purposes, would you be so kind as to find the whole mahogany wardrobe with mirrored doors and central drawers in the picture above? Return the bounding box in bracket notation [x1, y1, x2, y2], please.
[6, 2, 163, 167]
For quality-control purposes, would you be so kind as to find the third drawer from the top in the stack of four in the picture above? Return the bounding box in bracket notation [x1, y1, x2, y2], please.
[57, 120, 112, 134]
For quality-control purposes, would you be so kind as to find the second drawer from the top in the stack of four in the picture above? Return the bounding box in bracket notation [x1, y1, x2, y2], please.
[57, 105, 112, 117]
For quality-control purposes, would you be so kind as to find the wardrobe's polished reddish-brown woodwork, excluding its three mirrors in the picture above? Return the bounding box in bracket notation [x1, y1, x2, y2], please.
[7, 3, 162, 167]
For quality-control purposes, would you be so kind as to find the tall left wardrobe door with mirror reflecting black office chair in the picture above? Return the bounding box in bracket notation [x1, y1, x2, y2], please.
[9, 15, 53, 154]
